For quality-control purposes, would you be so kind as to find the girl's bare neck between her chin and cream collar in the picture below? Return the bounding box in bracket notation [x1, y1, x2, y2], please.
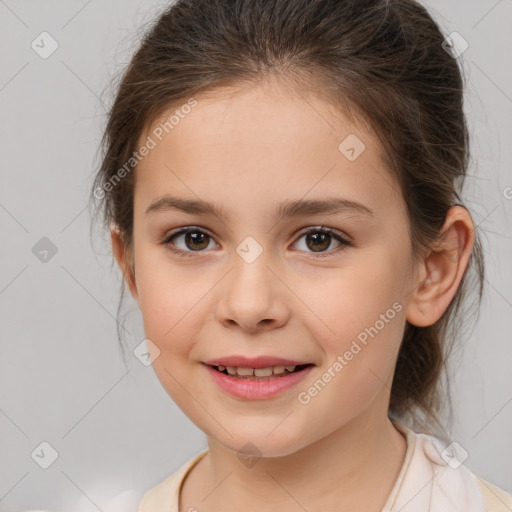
[180, 411, 406, 512]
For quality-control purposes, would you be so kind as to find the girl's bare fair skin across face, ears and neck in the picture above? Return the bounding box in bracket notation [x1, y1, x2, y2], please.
[112, 78, 474, 512]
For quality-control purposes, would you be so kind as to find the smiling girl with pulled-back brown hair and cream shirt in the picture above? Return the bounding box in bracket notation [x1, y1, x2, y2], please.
[93, 0, 512, 512]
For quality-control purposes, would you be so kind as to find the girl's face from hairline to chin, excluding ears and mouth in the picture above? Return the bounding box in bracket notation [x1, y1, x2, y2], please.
[121, 80, 424, 456]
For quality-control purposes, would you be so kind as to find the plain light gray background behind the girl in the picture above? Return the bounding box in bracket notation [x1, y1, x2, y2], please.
[0, 0, 512, 512]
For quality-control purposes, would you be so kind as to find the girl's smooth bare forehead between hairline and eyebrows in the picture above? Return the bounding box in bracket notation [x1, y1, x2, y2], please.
[136, 79, 401, 219]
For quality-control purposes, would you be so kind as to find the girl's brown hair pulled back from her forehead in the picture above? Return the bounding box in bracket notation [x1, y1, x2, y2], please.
[91, 0, 484, 432]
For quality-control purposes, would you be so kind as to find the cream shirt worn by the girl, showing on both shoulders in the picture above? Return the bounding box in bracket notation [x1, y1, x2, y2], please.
[138, 421, 512, 512]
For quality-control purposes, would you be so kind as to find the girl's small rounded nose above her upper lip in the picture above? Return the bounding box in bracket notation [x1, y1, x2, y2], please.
[216, 247, 290, 333]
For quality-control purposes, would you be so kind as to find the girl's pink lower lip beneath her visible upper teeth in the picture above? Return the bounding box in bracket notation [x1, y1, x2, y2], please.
[205, 365, 313, 400]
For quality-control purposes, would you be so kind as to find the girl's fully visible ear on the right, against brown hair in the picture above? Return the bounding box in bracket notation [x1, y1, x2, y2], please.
[406, 206, 475, 327]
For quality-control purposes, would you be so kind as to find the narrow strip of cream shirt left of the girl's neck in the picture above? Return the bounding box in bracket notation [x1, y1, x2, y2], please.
[138, 450, 208, 512]
